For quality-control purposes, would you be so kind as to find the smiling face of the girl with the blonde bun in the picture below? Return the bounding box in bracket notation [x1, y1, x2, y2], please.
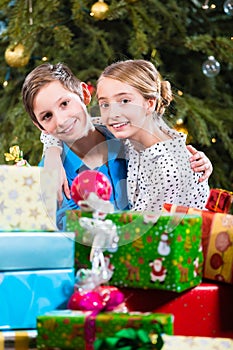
[97, 77, 154, 140]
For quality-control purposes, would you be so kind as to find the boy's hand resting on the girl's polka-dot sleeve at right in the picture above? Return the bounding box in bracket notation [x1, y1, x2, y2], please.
[186, 145, 213, 182]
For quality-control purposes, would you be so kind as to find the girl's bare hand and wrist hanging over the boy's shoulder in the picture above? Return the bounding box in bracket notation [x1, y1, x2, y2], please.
[44, 146, 71, 206]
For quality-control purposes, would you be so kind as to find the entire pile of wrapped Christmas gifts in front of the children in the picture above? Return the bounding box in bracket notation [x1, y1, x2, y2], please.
[0, 163, 233, 350]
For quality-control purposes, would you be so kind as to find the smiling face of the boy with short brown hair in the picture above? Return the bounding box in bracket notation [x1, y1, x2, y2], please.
[33, 81, 92, 144]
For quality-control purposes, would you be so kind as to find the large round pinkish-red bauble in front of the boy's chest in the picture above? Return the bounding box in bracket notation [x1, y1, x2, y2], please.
[71, 170, 112, 204]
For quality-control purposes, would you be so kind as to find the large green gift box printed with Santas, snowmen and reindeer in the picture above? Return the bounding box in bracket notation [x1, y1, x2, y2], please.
[66, 210, 203, 292]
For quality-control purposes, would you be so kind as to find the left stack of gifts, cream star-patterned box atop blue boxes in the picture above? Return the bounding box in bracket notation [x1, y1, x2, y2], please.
[0, 165, 74, 349]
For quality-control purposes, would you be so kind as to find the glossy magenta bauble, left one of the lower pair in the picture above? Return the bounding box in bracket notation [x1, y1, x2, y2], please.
[67, 291, 105, 311]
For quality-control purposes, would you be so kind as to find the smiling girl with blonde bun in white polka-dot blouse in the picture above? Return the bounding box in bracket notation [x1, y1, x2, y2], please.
[97, 60, 209, 212]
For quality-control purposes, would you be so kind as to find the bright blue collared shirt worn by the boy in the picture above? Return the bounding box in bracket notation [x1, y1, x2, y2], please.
[57, 125, 128, 231]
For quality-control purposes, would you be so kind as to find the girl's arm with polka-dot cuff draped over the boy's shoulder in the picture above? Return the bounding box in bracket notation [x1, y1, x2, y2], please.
[40, 133, 71, 206]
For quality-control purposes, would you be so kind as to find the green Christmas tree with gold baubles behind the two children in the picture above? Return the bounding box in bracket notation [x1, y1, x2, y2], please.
[0, 0, 233, 190]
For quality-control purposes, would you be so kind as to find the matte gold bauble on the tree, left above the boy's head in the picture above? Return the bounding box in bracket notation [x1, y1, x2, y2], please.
[5, 44, 30, 68]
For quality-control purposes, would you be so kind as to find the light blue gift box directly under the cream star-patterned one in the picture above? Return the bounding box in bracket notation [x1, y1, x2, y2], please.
[0, 232, 74, 271]
